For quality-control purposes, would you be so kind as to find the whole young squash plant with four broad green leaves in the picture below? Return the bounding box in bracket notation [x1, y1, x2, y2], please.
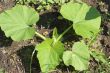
[0, 3, 101, 73]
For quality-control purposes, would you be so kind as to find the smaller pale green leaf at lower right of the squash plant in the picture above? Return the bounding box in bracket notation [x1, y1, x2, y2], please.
[63, 41, 90, 71]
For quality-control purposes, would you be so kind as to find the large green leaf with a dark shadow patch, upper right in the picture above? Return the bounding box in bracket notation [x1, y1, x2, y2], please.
[60, 3, 101, 38]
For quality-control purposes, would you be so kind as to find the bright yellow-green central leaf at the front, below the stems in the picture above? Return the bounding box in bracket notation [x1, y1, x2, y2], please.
[36, 39, 64, 72]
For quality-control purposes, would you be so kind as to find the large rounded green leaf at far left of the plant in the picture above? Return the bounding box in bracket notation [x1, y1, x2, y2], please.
[0, 5, 39, 41]
